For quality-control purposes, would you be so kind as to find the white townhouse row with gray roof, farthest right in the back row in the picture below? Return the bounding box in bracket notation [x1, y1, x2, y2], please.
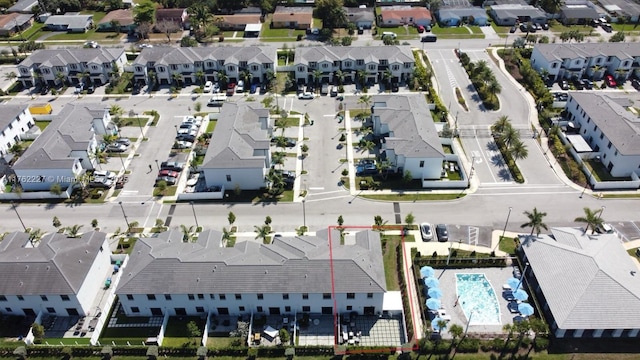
[531, 42, 640, 80]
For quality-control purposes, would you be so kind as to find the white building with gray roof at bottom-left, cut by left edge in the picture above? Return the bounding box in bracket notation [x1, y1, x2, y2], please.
[0, 231, 113, 318]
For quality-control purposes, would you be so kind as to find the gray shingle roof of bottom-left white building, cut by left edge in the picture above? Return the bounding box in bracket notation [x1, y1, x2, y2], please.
[0, 231, 106, 295]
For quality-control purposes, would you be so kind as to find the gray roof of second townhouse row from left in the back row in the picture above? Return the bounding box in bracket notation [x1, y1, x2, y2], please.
[134, 46, 276, 66]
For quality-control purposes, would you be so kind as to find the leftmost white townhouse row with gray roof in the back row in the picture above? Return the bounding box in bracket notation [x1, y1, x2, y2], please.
[17, 48, 127, 88]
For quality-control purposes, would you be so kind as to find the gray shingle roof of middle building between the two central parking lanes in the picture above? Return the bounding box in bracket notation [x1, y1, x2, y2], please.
[202, 103, 270, 169]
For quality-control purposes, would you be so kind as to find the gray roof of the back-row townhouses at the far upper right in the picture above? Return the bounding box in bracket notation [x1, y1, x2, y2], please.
[535, 42, 640, 61]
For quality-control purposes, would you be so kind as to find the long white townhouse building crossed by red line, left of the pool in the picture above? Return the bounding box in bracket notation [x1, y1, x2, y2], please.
[116, 230, 386, 316]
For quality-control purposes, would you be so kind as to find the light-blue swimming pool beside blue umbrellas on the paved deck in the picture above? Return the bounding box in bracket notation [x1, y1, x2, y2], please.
[456, 274, 502, 325]
